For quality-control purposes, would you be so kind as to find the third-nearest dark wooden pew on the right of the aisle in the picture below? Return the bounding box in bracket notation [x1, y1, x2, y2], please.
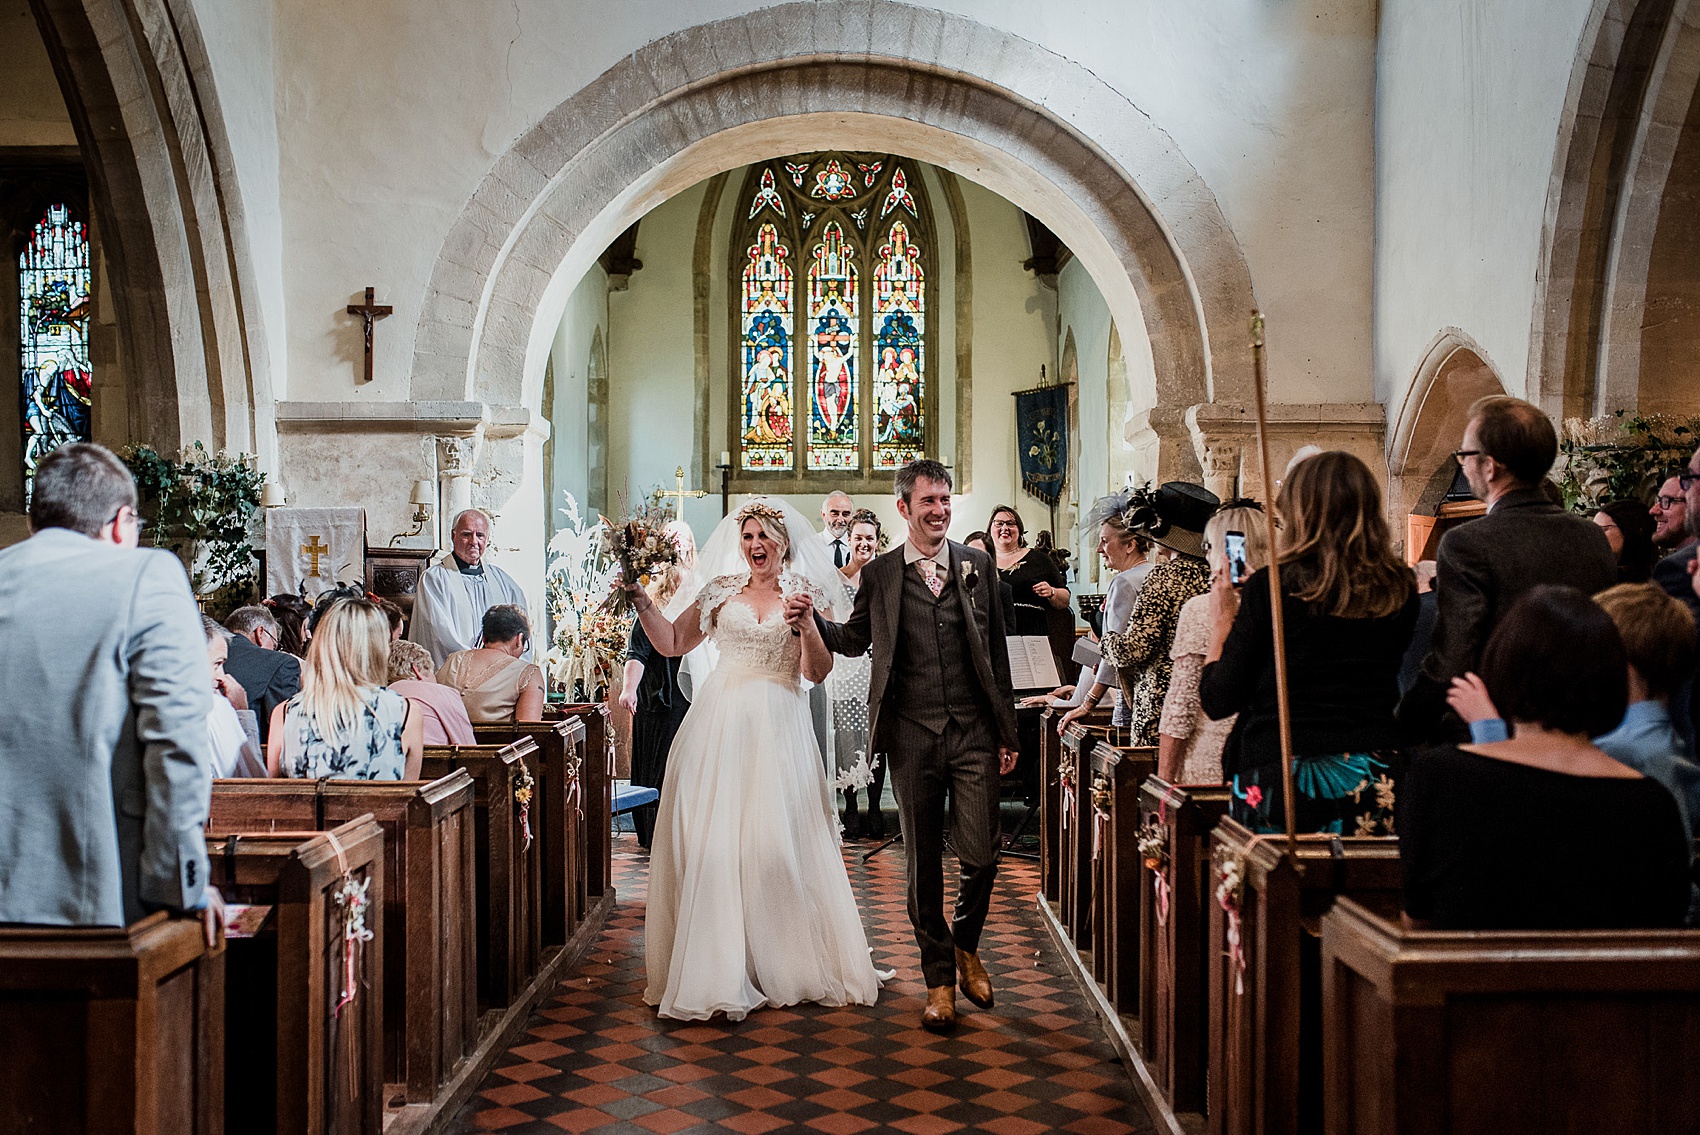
[1139, 776, 1229, 1115]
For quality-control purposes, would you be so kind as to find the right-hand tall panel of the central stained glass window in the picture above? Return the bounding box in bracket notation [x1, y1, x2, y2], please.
[874, 221, 927, 469]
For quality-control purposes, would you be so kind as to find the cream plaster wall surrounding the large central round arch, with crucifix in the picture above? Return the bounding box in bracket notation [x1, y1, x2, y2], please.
[274, 0, 1375, 414]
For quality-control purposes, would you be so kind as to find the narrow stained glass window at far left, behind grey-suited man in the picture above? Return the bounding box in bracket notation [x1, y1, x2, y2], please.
[17, 206, 94, 491]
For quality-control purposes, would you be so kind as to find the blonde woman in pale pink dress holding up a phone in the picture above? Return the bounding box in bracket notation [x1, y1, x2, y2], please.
[1158, 501, 1270, 785]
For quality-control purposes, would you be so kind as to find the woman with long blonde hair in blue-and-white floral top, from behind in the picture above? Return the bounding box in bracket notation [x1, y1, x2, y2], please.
[265, 600, 425, 780]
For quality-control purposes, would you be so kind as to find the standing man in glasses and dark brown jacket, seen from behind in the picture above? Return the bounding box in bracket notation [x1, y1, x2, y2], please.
[1399, 394, 1617, 739]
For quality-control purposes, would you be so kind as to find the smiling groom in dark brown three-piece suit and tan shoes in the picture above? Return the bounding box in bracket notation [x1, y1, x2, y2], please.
[787, 460, 1017, 1033]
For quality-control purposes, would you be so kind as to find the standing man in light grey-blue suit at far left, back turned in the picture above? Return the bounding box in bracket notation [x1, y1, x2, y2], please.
[0, 443, 223, 945]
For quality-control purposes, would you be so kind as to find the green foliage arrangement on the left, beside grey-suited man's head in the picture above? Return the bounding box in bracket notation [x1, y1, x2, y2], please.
[119, 442, 265, 617]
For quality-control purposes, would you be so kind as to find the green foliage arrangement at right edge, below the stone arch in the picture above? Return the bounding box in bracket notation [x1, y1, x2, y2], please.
[1559, 409, 1700, 511]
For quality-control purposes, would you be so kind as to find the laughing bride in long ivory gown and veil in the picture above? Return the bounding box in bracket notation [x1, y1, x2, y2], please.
[631, 498, 879, 1021]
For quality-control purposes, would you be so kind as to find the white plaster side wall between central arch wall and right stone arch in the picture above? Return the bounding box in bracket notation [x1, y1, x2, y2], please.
[1373, 0, 1591, 408]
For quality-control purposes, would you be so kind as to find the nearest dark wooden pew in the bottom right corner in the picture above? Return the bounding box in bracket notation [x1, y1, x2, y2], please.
[1323, 899, 1700, 1135]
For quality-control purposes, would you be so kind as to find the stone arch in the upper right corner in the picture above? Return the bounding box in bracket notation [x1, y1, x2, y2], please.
[1527, 0, 1700, 418]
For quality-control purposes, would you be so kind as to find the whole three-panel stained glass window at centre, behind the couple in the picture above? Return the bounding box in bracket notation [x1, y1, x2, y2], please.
[733, 151, 932, 479]
